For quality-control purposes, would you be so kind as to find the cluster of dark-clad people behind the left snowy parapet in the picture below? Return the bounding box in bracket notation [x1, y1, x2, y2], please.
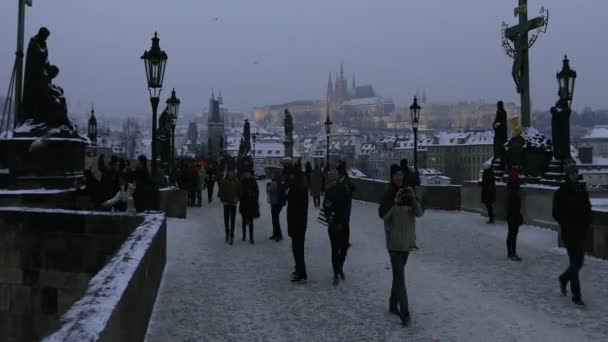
[77, 155, 156, 212]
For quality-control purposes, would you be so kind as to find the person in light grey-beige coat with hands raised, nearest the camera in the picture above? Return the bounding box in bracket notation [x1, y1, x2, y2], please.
[378, 164, 423, 326]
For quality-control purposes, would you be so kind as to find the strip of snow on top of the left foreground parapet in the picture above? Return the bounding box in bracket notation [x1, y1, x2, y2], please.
[43, 213, 165, 342]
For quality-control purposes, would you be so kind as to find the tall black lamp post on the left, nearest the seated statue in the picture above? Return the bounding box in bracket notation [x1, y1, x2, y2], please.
[141, 32, 167, 183]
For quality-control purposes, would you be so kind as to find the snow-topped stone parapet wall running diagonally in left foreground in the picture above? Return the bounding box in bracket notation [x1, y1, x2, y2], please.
[43, 214, 167, 342]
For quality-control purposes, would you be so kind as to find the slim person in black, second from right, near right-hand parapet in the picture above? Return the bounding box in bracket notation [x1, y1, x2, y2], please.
[507, 169, 524, 261]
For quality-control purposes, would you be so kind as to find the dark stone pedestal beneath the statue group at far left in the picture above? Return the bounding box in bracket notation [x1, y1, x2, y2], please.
[0, 137, 88, 189]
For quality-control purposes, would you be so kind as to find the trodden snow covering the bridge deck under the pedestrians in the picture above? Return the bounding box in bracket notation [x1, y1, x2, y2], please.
[147, 187, 608, 342]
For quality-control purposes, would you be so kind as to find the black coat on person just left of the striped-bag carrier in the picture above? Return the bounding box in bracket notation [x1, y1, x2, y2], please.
[287, 176, 308, 238]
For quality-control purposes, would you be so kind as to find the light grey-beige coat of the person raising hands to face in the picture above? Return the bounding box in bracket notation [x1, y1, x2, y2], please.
[378, 184, 423, 252]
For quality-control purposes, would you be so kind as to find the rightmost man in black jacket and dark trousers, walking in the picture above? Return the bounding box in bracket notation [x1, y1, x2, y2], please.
[553, 165, 591, 306]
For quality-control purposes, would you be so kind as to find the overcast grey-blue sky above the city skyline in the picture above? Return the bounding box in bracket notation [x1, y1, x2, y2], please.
[0, 0, 608, 115]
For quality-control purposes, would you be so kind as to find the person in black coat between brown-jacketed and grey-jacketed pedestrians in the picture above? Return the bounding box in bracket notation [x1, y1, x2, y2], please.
[239, 170, 260, 245]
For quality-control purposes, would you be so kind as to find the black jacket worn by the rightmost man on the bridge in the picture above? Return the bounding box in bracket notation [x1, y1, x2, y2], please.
[553, 181, 592, 244]
